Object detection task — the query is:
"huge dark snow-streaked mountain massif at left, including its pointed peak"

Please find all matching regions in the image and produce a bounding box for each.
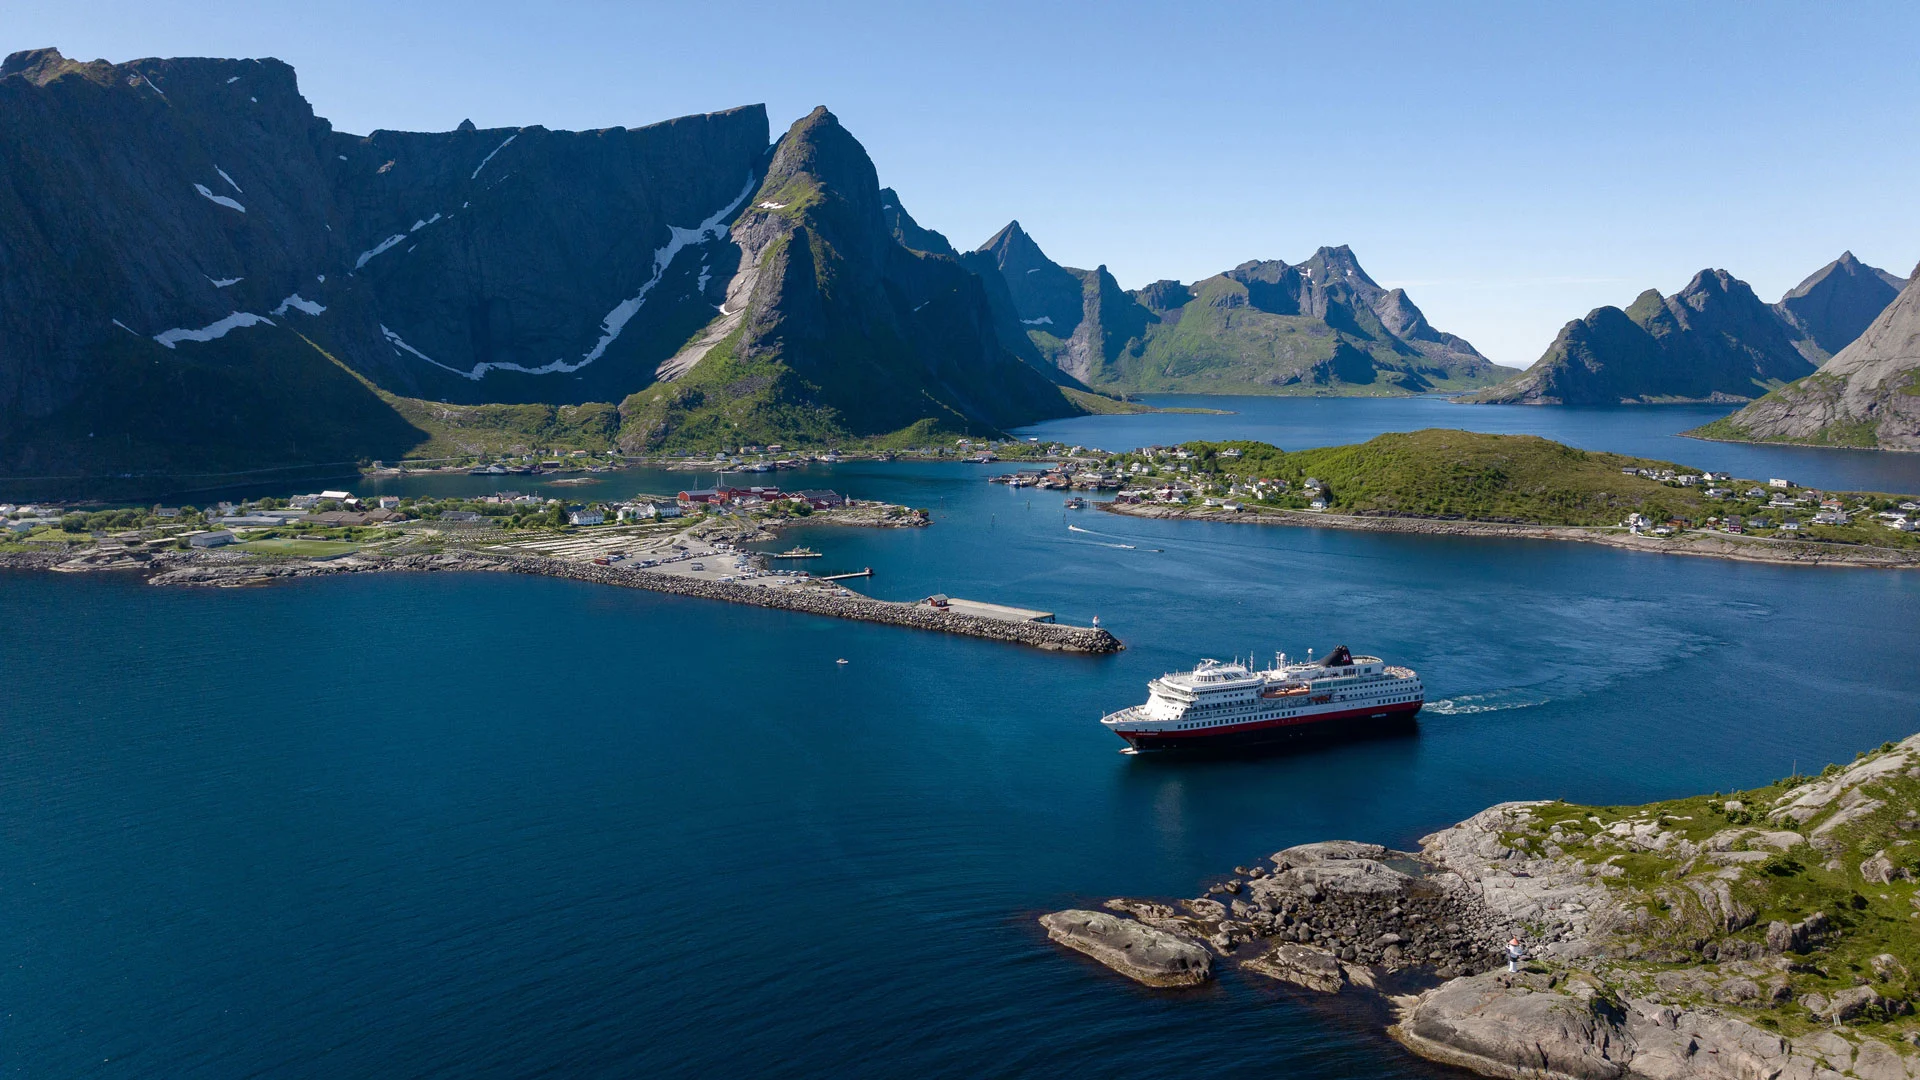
[0,50,1075,473]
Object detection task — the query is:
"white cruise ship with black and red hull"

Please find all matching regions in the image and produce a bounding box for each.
[1100,646,1427,753]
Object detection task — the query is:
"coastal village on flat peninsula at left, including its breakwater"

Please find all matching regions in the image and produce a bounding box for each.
[0,448,1121,653]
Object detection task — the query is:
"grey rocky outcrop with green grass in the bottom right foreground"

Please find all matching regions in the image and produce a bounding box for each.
[1041,734,1920,1080]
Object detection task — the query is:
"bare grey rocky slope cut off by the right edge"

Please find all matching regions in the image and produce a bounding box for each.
[1693,267,1920,450]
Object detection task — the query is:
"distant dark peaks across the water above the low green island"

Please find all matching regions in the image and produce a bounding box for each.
[1463,252,1905,405]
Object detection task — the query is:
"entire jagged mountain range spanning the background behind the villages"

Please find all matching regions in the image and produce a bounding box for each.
[0,48,1899,479]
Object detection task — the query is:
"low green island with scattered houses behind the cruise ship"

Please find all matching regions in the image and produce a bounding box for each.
[1106,429,1920,565]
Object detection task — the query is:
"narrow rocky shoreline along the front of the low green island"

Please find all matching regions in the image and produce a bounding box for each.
[1094,502,1920,569]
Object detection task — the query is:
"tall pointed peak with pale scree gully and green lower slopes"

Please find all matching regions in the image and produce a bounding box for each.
[622,108,1073,446]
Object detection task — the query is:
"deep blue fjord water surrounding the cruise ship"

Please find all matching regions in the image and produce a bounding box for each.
[0,397,1920,1076]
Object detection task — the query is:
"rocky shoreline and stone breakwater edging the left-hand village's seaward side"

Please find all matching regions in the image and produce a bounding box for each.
[0,548,1123,655]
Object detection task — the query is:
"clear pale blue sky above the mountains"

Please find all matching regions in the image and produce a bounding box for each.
[0,0,1920,367]
